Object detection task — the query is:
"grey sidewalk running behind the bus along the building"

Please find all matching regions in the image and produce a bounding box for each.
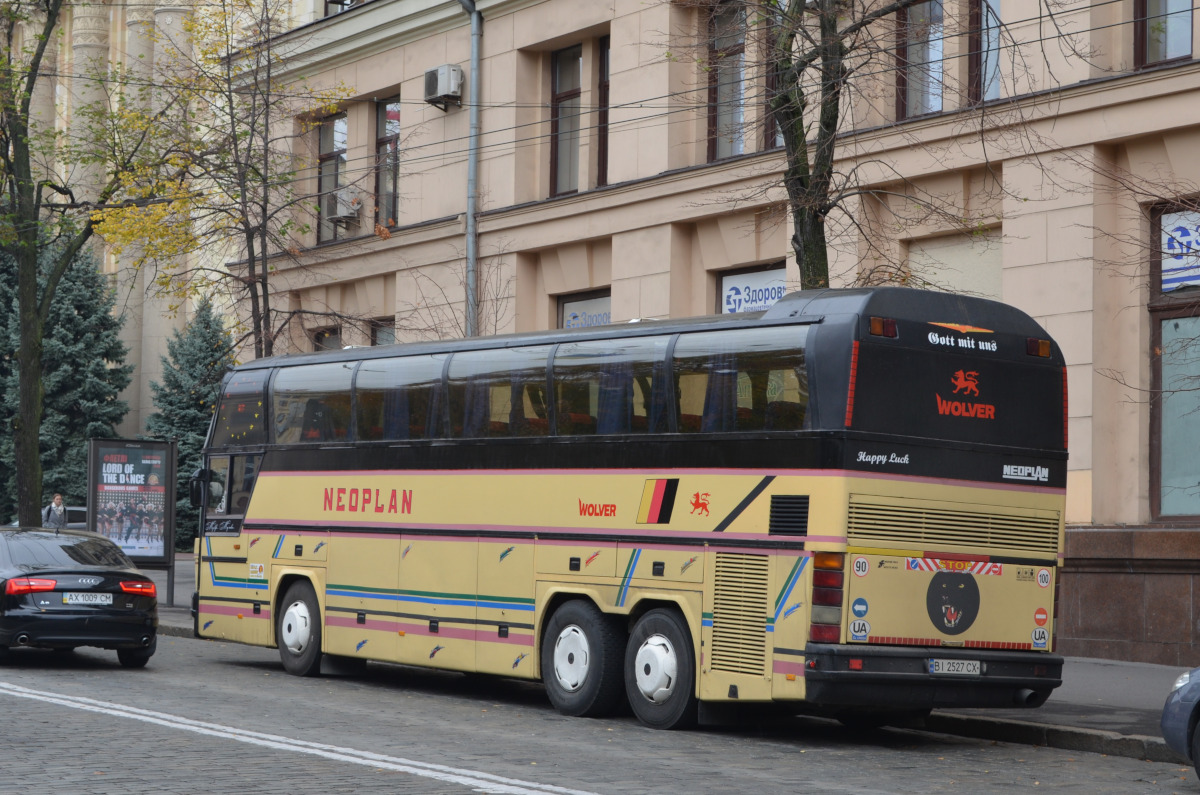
[146,552,1187,764]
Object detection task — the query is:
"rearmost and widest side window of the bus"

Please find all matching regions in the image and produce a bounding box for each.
[672,327,809,434]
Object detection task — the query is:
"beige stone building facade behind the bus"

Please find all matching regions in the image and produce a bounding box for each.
[87,0,1200,664]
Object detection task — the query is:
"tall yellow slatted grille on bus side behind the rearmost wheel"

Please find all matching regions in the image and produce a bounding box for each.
[709,552,768,675]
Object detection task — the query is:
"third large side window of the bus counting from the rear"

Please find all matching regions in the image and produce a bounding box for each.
[448,345,550,438]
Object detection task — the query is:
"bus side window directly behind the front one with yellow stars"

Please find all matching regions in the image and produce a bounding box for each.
[271,361,354,444]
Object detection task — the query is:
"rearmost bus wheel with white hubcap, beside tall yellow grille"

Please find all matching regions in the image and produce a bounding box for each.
[625,608,697,729]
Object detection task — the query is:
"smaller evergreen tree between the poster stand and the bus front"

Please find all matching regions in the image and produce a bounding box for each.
[146,299,234,549]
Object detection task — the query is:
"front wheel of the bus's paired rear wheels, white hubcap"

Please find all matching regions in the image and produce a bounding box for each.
[541,599,625,717]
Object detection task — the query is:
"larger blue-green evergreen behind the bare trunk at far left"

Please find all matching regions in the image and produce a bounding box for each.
[0,247,133,518]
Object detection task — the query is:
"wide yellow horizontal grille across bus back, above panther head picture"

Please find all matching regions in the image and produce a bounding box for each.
[847,495,1062,555]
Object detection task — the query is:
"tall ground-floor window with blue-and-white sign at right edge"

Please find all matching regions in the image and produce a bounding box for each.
[1150,207,1200,520]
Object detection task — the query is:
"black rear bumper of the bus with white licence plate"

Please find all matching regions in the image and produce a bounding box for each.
[804,644,1063,710]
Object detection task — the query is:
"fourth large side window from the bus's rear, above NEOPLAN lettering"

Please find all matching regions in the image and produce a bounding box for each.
[354,354,446,441]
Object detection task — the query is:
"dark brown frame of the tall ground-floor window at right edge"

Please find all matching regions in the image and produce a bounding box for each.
[1146,199,1200,525]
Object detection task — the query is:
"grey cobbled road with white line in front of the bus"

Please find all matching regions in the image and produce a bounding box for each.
[0,636,1200,795]
